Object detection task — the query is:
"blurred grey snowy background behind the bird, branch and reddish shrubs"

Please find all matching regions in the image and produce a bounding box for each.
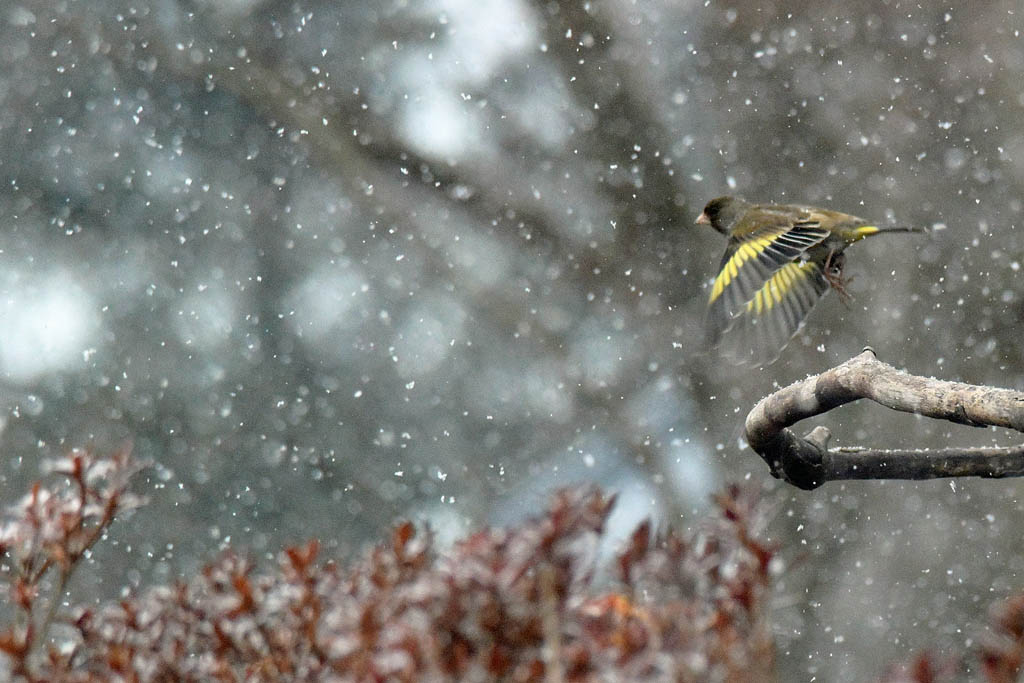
[0,0,1024,681]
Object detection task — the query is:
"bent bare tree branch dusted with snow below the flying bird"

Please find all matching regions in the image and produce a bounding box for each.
[746,348,1024,489]
